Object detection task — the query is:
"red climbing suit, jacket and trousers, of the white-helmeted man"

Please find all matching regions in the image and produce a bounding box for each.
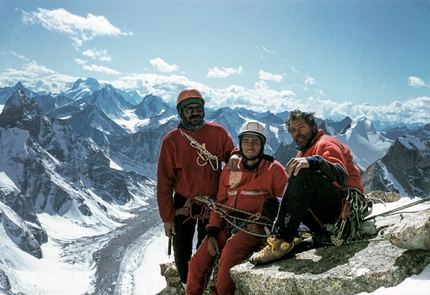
[186,160,287,295]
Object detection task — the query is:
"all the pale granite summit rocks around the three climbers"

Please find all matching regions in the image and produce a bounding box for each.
[160,199,430,295]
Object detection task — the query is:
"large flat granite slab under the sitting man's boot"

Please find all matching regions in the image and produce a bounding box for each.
[231,241,430,295]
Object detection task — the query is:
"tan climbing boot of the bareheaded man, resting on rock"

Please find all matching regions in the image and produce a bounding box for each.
[249,237,295,265]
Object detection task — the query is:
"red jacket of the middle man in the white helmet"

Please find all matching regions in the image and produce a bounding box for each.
[206,159,288,228]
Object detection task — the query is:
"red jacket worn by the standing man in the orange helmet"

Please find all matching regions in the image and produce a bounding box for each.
[157,122,234,222]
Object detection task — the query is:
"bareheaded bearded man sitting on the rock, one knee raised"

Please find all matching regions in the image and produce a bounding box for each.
[250,110,364,265]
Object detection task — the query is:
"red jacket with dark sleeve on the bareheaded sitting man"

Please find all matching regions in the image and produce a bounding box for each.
[297,129,364,194]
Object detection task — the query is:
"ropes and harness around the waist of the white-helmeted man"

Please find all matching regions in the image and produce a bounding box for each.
[195,196,272,238]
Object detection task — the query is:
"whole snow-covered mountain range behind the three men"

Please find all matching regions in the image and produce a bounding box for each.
[0,78,430,294]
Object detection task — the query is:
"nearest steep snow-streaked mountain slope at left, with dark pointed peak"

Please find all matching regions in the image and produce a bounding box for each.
[0,91,159,294]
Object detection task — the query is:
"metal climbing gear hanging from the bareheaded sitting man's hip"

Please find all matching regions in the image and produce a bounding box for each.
[325,190,376,246]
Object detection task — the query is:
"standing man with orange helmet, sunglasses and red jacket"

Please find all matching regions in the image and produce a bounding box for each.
[157,89,234,285]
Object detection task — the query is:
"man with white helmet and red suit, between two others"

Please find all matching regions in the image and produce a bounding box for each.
[186,121,287,294]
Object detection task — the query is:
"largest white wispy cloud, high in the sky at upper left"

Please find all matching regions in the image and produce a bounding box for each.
[22,8,133,46]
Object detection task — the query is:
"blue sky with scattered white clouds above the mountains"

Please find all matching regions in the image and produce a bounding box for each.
[0,0,430,123]
